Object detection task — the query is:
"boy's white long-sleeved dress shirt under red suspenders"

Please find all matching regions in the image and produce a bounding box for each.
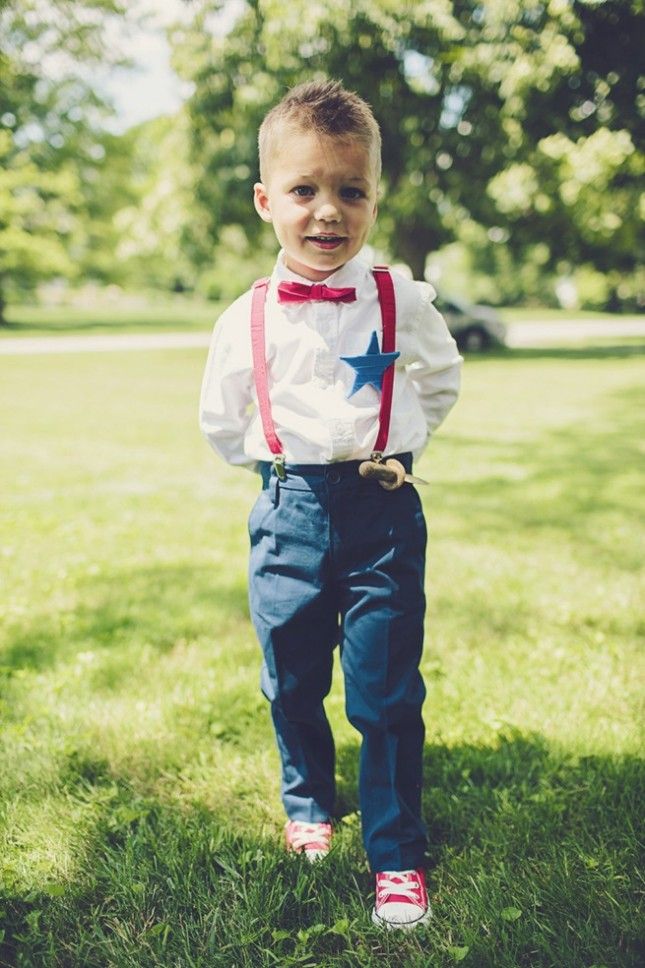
[200,252,462,467]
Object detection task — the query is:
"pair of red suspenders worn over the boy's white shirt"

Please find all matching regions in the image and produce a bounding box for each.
[251,266,396,466]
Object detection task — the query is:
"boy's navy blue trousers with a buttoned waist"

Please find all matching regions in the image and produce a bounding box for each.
[249,454,427,871]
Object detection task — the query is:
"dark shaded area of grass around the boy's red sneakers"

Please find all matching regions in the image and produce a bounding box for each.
[0,734,643,968]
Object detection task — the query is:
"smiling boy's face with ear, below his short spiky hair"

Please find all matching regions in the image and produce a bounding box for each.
[254,126,377,282]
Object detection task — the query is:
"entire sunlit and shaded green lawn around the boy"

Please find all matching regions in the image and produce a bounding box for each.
[0,347,645,968]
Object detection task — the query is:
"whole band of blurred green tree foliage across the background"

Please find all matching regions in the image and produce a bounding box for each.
[0,0,645,313]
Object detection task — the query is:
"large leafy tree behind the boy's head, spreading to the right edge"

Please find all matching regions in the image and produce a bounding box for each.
[175,0,643,304]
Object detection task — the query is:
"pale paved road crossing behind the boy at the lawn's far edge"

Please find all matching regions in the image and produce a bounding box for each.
[0,316,645,356]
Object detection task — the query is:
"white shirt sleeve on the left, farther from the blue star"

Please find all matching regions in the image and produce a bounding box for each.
[199,294,256,469]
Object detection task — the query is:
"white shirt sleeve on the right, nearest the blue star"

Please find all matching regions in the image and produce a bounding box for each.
[406,283,463,437]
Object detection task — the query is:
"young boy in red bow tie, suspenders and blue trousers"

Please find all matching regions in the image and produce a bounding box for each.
[201,82,461,929]
